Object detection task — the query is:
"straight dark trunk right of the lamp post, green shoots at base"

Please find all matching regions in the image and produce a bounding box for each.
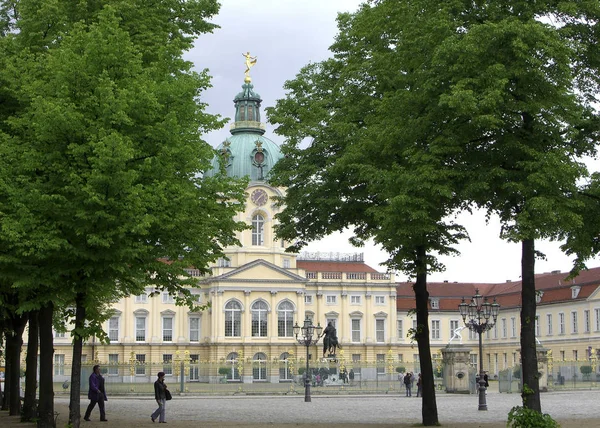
[521,239,542,413]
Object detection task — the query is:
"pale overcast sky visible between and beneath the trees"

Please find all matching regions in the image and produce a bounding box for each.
[188,0,600,282]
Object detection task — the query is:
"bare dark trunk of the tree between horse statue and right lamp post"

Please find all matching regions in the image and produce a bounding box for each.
[413,247,439,426]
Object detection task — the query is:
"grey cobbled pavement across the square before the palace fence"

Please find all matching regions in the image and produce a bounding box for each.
[48,390,600,427]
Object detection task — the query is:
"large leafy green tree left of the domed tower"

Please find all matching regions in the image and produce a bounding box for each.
[0,0,245,426]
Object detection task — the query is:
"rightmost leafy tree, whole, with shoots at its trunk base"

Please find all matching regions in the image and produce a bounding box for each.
[426,1,600,412]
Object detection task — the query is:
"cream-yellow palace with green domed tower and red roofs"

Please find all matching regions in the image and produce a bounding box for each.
[50,72,600,383]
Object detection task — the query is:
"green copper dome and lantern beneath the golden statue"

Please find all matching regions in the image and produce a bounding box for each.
[206,82,283,181]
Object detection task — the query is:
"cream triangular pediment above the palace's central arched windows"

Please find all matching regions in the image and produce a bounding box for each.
[209,259,307,284]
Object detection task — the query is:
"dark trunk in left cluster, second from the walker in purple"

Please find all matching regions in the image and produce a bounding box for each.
[38,302,56,428]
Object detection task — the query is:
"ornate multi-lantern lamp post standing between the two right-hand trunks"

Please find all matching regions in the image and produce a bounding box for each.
[458,289,500,410]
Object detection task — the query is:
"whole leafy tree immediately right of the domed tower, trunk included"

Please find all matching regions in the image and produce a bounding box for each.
[268,1,474,426]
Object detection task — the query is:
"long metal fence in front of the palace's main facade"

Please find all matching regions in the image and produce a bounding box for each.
[49,361,443,395]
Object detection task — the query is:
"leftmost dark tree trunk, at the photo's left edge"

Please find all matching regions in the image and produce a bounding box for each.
[6,315,27,416]
